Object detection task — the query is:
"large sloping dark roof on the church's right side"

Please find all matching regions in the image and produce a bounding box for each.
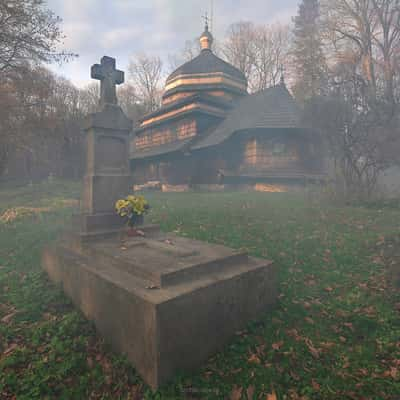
[192,84,301,150]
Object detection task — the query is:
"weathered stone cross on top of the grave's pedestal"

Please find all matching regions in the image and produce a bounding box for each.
[91,56,124,107]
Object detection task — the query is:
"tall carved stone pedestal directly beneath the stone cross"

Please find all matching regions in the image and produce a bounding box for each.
[81,105,132,234]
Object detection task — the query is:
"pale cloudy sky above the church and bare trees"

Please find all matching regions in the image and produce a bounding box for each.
[48,0,298,86]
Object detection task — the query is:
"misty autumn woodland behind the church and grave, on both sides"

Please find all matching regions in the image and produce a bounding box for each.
[0,0,400,197]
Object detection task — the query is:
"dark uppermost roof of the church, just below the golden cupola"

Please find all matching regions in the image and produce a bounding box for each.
[167,49,247,84]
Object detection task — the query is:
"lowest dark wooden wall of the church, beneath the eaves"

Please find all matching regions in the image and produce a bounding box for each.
[132,132,321,185]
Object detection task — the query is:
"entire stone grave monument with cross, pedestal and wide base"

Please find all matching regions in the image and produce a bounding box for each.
[43,57,277,388]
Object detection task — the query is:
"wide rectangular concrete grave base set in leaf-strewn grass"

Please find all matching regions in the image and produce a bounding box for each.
[43,227,277,389]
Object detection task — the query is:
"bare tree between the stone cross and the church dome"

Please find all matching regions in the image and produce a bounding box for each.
[128,54,163,112]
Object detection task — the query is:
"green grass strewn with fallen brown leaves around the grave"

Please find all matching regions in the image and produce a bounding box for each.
[0,182,400,400]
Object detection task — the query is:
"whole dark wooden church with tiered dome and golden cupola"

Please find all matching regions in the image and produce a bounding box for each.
[131,25,323,191]
